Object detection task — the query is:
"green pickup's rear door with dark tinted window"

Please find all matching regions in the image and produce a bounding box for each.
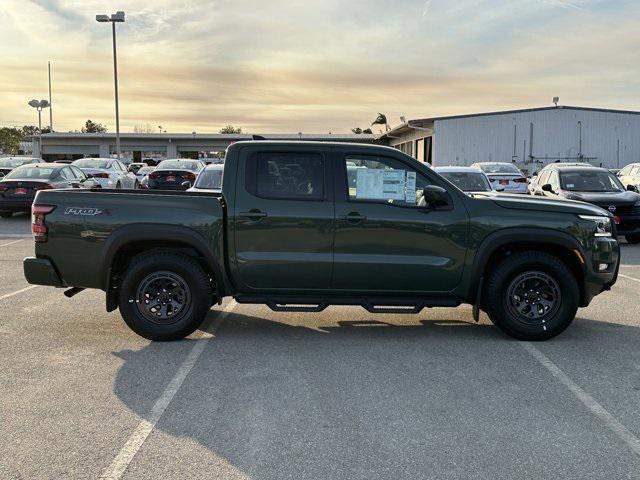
[232,146,334,293]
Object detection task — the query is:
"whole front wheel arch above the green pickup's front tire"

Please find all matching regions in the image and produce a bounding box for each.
[468,228,586,303]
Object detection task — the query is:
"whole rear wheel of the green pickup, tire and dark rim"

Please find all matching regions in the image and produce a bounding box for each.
[118,251,211,341]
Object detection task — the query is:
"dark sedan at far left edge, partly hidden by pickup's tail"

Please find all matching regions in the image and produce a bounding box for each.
[0,162,99,218]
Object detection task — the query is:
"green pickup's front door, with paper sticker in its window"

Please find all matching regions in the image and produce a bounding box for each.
[332,155,468,294]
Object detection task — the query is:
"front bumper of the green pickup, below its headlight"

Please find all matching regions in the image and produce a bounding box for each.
[580,237,620,307]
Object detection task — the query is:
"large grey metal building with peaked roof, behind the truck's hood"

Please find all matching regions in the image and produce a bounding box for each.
[378,106,640,173]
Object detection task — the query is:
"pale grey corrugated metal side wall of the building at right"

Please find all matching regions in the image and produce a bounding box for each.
[434,108,640,171]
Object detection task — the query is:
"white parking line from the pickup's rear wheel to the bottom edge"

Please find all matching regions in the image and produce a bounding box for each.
[100,300,238,480]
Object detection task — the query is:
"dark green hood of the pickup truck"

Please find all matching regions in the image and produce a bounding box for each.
[472,192,612,217]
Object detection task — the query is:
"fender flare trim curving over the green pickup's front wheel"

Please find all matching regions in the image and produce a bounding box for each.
[468,227,587,299]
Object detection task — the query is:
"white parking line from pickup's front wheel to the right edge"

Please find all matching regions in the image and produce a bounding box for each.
[521,342,640,456]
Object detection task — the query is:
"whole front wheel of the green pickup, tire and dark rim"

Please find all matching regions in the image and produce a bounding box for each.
[483,251,580,340]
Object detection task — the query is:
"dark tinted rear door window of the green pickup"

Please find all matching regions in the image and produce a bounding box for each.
[249,152,324,200]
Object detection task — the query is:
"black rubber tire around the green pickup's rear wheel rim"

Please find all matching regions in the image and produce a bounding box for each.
[118,250,212,341]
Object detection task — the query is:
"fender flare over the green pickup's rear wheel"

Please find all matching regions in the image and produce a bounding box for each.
[100,223,226,297]
